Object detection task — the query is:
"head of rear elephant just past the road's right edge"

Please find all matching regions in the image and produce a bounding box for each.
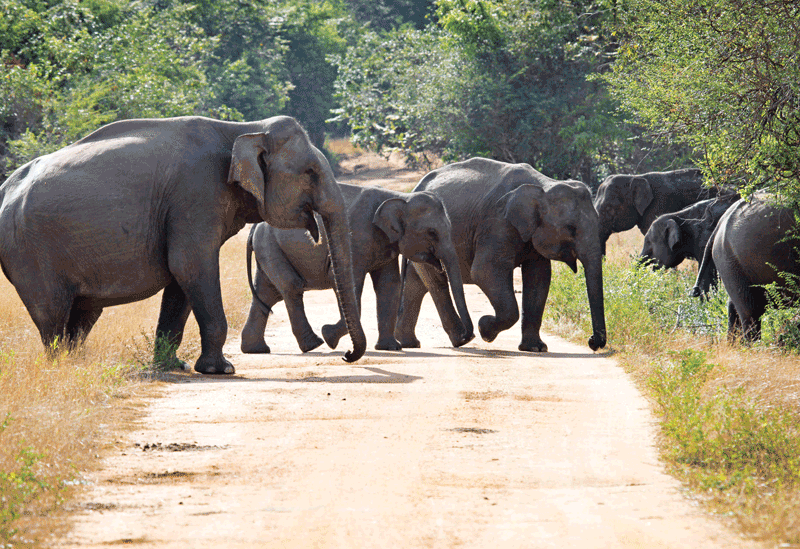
[594,175,654,254]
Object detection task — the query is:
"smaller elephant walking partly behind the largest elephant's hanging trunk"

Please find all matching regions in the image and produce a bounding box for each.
[241,184,475,353]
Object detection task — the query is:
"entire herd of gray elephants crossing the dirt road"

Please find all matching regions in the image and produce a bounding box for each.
[0,116,798,374]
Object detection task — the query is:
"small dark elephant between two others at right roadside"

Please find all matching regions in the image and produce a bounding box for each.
[640,194,739,268]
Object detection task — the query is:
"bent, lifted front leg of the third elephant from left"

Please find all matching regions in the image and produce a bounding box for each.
[470,250,519,342]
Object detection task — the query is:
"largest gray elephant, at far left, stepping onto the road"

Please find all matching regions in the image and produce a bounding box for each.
[0,116,366,374]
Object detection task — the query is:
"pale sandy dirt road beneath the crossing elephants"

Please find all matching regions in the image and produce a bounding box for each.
[61,272,755,549]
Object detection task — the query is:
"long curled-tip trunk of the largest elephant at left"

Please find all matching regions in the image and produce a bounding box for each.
[314,180,367,362]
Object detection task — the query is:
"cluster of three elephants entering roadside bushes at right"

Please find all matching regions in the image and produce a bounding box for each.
[595,170,800,341]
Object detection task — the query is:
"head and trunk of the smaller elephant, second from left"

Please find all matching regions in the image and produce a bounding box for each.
[372,192,474,339]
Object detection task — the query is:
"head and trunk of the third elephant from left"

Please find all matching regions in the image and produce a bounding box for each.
[501,181,606,351]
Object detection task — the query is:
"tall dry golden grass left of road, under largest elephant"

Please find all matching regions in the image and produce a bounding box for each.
[0,232,250,547]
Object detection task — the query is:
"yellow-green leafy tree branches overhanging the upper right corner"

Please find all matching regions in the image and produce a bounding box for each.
[608,0,800,196]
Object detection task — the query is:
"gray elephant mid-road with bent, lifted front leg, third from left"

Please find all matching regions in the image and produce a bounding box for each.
[395,158,606,352]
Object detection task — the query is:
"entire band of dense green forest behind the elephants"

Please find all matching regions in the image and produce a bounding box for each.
[0,0,800,197]
